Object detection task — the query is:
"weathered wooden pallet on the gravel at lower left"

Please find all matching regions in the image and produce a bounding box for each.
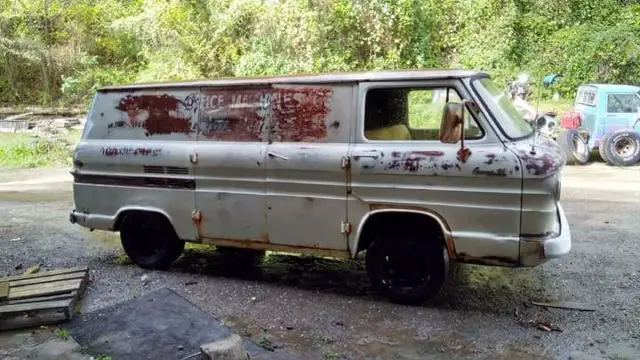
[0,266,89,330]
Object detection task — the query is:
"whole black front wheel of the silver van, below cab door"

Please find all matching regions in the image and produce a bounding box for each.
[366,228,449,304]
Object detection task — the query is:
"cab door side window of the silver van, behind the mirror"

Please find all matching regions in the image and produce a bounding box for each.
[364,88,483,141]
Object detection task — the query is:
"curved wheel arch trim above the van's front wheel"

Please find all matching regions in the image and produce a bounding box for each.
[350,206,456,259]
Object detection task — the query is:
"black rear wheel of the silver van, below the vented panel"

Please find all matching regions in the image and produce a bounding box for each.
[120,211,184,269]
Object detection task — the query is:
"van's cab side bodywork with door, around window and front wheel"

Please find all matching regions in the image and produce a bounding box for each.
[349,80,522,265]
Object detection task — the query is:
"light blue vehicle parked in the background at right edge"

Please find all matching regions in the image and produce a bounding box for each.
[559,84,640,166]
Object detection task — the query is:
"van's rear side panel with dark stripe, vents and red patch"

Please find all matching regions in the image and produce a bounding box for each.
[73,89,199,240]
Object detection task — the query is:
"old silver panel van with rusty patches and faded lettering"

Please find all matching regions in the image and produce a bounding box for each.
[70,70,571,303]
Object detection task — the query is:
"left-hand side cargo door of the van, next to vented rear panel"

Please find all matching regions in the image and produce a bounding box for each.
[195,87,267,242]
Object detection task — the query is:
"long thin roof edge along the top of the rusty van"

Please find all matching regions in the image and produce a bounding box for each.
[99,69,488,91]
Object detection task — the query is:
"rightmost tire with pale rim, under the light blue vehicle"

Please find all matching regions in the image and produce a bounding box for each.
[601,129,640,166]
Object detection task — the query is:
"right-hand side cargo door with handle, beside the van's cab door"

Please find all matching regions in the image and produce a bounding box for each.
[266,85,353,255]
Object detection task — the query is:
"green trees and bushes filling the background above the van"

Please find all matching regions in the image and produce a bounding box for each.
[0,0,640,105]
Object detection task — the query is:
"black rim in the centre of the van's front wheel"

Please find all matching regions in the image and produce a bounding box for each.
[382,239,431,288]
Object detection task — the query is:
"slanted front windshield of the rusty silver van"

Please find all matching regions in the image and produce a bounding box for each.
[473,78,534,140]
